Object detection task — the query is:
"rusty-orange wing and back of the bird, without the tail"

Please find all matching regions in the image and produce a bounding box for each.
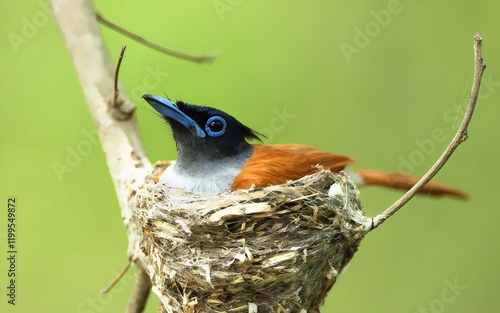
[231,144,354,190]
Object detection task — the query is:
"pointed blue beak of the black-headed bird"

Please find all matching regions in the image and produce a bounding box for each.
[142,94,206,138]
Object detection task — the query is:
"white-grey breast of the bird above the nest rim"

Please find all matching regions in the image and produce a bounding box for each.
[160,163,241,194]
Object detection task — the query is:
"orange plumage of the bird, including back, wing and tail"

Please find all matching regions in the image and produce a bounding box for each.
[231,144,467,199]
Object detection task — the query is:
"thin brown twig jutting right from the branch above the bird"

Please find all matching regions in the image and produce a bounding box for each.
[95,11,216,63]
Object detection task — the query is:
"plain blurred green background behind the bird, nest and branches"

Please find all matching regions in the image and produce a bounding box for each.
[0,0,500,313]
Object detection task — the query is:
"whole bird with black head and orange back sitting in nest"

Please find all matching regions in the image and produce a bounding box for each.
[142,94,468,200]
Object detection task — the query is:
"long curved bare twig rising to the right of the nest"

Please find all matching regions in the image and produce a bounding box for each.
[372,34,486,230]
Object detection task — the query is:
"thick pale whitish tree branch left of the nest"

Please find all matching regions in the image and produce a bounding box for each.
[52,0,151,313]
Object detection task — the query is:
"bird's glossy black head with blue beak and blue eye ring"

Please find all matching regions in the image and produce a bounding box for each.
[142,94,260,166]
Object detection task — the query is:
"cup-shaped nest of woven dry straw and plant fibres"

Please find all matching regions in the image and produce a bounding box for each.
[135,162,371,313]
